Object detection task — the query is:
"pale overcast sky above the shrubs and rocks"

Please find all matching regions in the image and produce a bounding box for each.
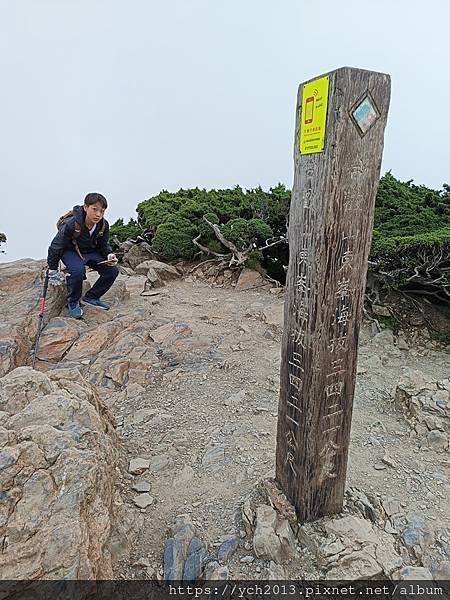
[0,0,450,261]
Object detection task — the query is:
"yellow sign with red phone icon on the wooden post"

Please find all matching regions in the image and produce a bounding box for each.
[300,77,329,154]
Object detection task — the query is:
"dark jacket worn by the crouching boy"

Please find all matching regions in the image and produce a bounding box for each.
[47,206,112,269]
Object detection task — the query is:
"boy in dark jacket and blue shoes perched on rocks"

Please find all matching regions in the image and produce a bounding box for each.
[47,194,119,319]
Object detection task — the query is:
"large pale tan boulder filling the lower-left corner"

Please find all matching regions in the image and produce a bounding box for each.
[0,367,118,580]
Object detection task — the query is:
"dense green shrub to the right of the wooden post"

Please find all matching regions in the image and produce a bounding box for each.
[370,173,450,302]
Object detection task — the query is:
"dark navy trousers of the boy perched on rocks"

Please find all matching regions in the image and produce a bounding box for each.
[61,250,119,304]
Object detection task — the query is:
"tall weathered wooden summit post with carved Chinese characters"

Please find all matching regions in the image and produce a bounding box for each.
[276,67,390,521]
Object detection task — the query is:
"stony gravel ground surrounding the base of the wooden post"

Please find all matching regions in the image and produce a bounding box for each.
[0,258,450,579]
